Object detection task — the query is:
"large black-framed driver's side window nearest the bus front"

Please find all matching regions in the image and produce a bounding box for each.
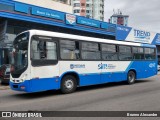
[31,36,58,66]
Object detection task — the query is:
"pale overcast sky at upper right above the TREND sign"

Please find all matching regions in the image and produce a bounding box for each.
[105,0,160,33]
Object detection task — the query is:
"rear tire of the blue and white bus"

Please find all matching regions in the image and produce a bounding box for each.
[127,71,136,85]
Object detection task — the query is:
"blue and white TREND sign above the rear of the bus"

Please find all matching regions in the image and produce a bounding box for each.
[116,25,160,45]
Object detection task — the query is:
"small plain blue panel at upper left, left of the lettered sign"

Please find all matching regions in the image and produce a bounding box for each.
[15,3,29,13]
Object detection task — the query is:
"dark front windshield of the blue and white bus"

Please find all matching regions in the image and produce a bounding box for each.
[11,33,29,75]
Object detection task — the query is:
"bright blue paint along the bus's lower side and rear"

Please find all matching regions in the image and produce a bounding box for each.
[10,61,157,92]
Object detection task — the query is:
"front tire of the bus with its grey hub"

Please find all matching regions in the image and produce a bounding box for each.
[61,75,77,94]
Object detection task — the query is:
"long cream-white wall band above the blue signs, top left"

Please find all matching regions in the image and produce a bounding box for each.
[14,0,73,13]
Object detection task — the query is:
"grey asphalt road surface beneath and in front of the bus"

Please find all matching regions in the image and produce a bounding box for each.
[0,75,160,120]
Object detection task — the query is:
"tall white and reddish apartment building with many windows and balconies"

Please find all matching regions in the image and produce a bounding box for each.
[71,0,104,21]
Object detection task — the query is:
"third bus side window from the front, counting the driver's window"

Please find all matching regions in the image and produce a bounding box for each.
[81,42,101,60]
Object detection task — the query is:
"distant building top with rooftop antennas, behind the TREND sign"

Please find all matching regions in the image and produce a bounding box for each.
[109,11,129,26]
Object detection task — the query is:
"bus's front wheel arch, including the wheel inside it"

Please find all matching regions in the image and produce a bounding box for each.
[61,73,79,94]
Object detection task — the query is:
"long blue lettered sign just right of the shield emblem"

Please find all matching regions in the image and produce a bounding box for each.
[77,17,100,28]
